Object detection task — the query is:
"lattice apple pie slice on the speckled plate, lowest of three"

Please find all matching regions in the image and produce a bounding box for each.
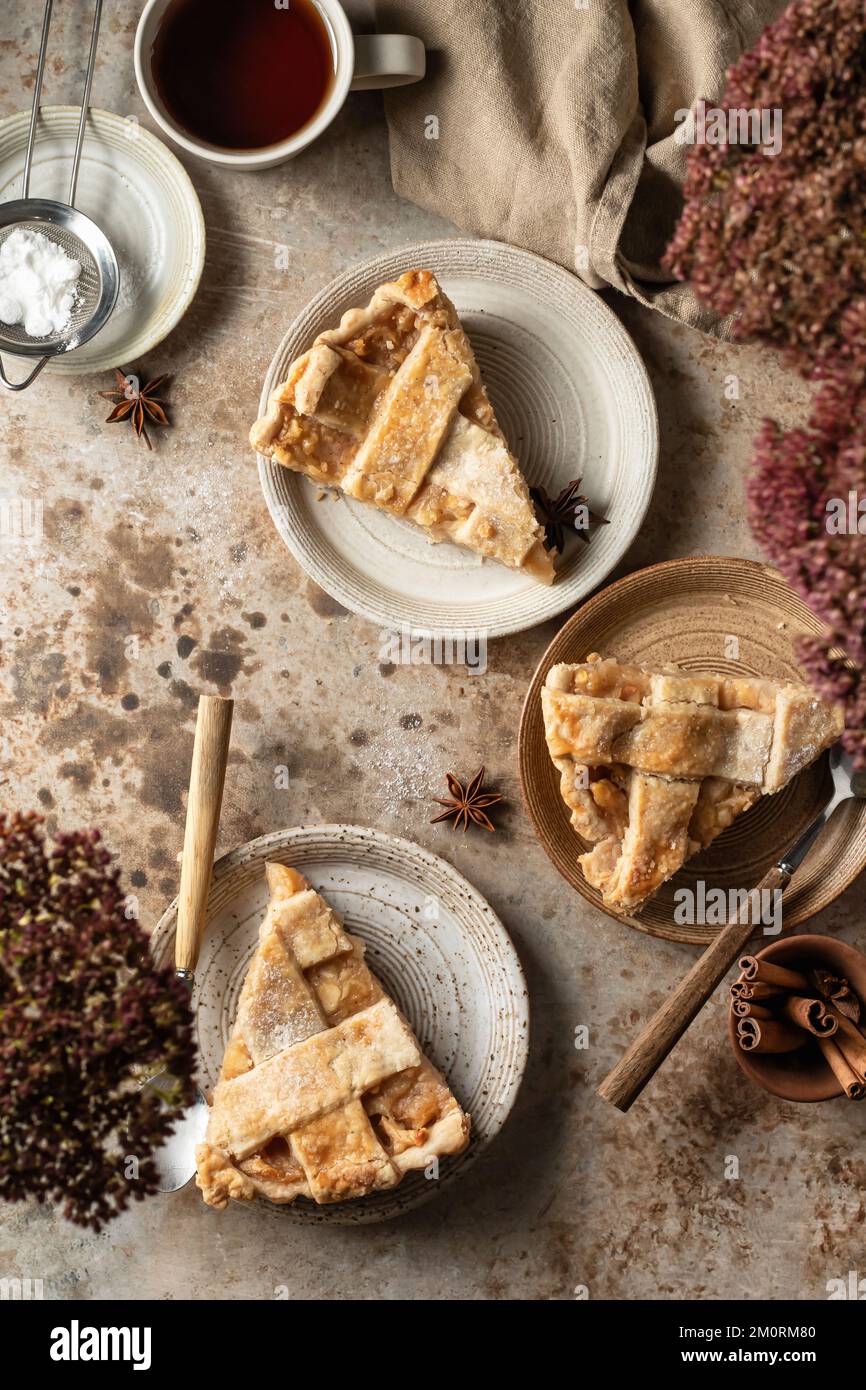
[196,863,470,1208]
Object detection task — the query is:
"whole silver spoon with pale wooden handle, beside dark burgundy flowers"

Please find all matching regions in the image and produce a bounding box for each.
[142,695,235,1193]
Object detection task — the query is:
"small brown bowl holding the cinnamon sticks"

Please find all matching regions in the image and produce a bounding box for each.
[728,935,866,1101]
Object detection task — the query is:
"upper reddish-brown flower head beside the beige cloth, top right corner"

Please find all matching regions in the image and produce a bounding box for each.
[666,0,866,375]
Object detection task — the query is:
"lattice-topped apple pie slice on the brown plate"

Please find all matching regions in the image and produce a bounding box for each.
[541,653,842,912]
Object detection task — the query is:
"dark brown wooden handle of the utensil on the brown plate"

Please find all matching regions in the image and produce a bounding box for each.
[598,865,791,1111]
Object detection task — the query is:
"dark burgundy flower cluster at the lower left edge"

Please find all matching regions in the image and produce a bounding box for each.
[0,813,195,1230]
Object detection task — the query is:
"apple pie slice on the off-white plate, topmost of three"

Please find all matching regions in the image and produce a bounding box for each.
[250,270,553,584]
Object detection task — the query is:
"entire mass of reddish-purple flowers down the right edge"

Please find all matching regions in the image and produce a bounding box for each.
[667,0,866,766]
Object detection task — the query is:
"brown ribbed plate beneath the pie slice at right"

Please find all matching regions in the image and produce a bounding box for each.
[518,555,866,945]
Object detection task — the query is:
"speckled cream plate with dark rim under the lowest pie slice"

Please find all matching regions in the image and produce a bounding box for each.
[153,826,530,1226]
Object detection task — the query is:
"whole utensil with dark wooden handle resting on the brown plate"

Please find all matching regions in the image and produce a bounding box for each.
[598,744,866,1111]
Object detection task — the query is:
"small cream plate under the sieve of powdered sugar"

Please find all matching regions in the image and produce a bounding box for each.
[0,106,204,375]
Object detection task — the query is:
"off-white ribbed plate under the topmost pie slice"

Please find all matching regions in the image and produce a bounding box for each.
[250,240,657,637]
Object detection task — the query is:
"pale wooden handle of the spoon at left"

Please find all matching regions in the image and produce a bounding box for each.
[174,695,235,972]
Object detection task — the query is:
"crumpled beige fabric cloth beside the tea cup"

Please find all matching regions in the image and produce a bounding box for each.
[377,0,785,329]
